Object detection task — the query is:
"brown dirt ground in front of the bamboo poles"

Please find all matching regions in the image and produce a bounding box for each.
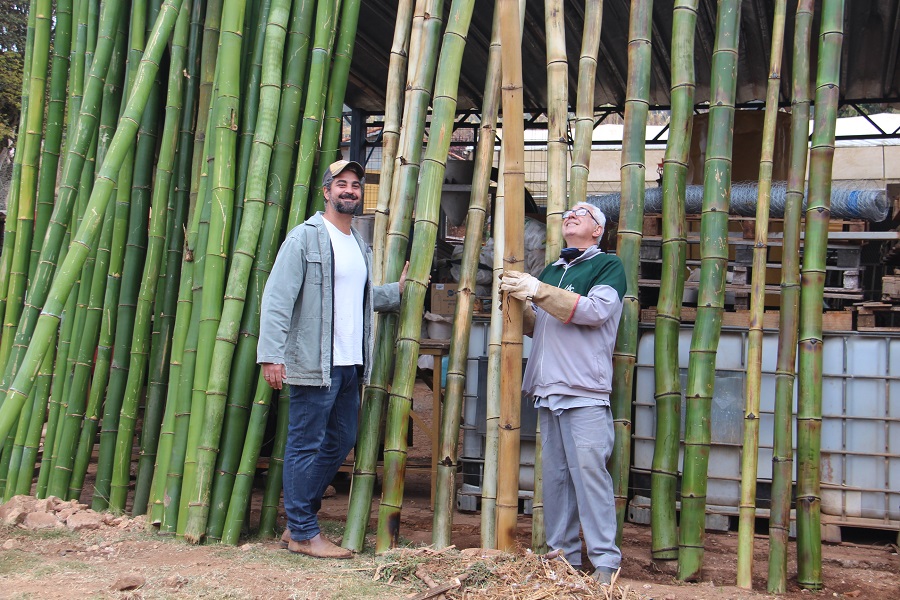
[0,385,900,600]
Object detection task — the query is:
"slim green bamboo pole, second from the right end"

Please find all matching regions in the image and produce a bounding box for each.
[768,0,814,594]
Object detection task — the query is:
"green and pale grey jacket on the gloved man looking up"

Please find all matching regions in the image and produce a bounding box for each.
[522,247,625,404]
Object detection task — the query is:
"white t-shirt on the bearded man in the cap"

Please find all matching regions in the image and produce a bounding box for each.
[324,219,368,366]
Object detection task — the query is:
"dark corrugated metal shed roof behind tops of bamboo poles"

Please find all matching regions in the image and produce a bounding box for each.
[346,0,900,113]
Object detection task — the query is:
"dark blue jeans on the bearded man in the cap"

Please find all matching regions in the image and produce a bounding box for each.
[284,366,359,541]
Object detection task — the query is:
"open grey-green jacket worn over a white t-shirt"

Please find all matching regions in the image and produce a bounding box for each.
[256,212,400,387]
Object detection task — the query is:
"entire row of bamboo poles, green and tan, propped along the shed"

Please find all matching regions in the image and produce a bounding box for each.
[0,0,844,591]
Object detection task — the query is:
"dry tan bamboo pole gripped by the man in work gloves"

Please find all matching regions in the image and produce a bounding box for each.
[496,0,525,551]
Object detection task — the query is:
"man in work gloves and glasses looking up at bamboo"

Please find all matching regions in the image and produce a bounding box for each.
[500,203,625,583]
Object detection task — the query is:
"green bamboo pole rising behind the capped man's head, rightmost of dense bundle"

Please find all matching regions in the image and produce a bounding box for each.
[312,0,362,211]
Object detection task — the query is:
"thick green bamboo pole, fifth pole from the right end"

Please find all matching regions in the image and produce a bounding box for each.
[650,0,699,560]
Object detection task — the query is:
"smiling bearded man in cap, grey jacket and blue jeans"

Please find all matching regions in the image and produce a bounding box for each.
[257,160,406,558]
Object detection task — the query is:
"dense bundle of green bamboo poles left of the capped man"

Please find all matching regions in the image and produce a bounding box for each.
[0,0,368,543]
